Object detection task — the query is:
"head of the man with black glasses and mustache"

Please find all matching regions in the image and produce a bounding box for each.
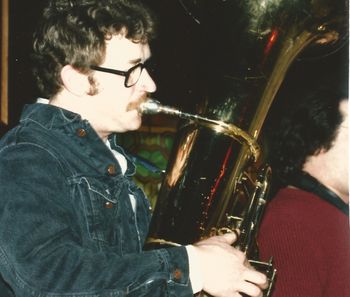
[33,0,155,137]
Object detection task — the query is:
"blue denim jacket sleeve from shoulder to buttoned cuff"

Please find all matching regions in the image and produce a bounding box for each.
[0,144,192,297]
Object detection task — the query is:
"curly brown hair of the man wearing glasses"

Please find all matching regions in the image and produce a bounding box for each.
[33,0,155,98]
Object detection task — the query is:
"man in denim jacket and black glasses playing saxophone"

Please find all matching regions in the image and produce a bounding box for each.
[0,0,266,297]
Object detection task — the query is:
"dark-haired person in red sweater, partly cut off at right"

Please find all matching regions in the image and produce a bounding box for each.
[258,78,350,297]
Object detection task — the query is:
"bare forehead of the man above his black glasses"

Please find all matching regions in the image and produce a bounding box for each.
[103,34,151,65]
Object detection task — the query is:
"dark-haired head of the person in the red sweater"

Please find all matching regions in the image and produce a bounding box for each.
[269,84,348,200]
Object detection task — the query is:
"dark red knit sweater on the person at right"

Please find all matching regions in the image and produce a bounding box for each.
[258,188,350,297]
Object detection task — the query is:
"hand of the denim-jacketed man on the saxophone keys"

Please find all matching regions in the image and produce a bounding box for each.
[193,233,267,297]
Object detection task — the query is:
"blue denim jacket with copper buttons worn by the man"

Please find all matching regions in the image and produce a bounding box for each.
[0,103,192,297]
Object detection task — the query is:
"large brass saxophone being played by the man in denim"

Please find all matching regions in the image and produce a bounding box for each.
[140,0,348,296]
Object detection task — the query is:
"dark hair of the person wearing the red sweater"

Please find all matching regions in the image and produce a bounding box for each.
[267,83,348,185]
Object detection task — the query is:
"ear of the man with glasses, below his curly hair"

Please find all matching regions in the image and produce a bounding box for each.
[61,65,91,96]
